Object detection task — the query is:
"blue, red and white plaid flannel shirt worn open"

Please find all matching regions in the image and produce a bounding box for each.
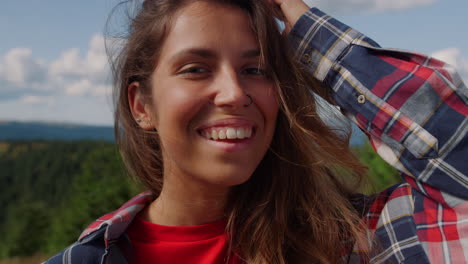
[46,8,468,264]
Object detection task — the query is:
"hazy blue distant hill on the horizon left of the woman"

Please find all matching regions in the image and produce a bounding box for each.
[0,121,114,142]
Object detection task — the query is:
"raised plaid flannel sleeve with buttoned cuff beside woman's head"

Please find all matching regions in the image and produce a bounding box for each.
[289,8,468,204]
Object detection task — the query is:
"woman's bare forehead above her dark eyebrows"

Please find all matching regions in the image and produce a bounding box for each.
[161,1,258,56]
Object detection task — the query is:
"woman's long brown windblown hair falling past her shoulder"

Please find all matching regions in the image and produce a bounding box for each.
[110,0,372,264]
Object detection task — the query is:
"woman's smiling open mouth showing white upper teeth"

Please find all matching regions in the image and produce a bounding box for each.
[199,126,255,142]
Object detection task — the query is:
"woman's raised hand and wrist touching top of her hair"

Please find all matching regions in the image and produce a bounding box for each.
[268,0,309,34]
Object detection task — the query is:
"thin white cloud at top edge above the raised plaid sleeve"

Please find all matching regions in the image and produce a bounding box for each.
[305,0,436,14]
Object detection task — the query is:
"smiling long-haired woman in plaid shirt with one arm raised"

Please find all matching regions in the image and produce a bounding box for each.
[47,0,468,263]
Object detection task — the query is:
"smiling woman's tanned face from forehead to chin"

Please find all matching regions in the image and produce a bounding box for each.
[146,1,278,187]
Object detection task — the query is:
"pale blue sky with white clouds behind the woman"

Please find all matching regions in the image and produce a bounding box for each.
[0,0,468,125]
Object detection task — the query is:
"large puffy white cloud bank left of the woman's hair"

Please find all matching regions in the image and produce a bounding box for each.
[0,35,111,100]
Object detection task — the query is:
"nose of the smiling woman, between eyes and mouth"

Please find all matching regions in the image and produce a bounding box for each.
[213,71,249,108]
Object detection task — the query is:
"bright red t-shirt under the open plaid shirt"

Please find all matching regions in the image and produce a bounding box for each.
[127,216,240,264]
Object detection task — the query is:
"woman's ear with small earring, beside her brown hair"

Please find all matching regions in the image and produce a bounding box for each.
[127,82,155,130]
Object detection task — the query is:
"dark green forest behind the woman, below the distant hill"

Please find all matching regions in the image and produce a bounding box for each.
[0,141,399,263]
